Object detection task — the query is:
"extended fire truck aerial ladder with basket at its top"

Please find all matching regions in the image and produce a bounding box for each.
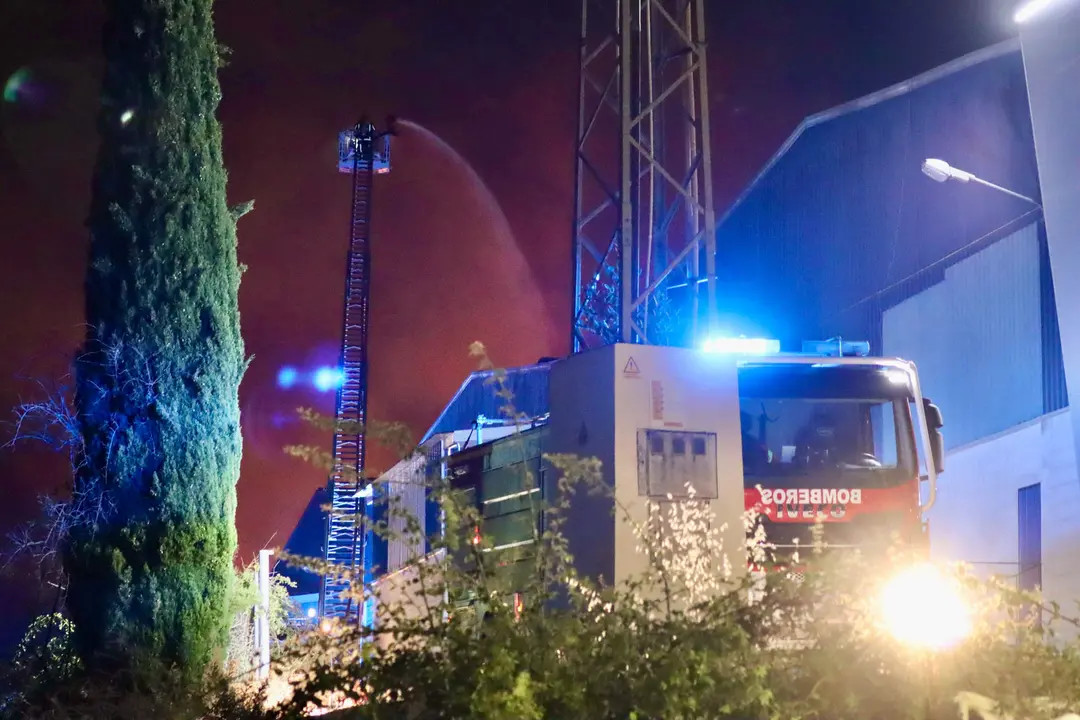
[319,120,392,622]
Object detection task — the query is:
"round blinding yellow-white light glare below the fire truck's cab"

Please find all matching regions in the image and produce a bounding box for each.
[881,562,971,650]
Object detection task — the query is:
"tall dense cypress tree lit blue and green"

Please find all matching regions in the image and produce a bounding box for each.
[65,0,245,677]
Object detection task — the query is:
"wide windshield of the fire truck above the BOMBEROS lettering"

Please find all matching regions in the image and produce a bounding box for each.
[739,364,917,487]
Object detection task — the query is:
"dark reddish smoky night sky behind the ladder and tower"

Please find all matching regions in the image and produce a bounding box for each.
[0,0,1014,651]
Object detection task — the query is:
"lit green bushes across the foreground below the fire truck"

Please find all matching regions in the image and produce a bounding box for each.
[252,345,1080,720]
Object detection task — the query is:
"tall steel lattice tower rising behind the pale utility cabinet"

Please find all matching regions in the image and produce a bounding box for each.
[571,0,717,352]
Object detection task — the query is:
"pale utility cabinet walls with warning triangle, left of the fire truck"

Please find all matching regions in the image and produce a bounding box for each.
[548,344,745,583]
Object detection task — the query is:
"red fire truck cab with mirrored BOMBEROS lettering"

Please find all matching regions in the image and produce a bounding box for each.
[721,340,944,558]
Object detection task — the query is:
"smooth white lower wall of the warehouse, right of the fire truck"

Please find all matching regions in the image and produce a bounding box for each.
[930,409,1080,610]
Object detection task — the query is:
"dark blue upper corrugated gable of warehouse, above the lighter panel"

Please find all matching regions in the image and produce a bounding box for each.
[717,44,1038,352]
